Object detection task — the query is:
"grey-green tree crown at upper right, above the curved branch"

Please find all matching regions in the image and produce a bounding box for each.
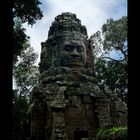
[102,17,127,52]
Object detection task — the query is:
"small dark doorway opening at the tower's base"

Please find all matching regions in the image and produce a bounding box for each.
[74,128,88,140]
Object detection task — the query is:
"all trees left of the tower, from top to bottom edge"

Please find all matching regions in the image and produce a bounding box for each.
[12,0,43,140]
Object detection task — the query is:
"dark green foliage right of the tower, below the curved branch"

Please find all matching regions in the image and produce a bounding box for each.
[95,58,128,103]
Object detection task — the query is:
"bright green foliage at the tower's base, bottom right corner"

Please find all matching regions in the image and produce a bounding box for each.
[96,127,128,140]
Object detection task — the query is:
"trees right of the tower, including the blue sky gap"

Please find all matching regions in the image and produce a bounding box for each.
[90,16,128,103]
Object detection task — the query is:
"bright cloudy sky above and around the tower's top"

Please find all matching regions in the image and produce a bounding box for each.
[23,0,127,64]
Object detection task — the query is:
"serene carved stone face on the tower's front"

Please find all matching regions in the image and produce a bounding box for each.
[60,41,86,67]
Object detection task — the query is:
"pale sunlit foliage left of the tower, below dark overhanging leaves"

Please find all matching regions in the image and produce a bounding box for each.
[13,47,39,96]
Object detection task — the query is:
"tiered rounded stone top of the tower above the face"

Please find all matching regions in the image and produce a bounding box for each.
[48,12,87,38]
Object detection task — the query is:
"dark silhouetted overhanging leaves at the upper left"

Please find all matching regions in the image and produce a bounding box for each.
[13,0,43,64]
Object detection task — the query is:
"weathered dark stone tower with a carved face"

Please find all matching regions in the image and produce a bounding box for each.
[29,12,127,140]
